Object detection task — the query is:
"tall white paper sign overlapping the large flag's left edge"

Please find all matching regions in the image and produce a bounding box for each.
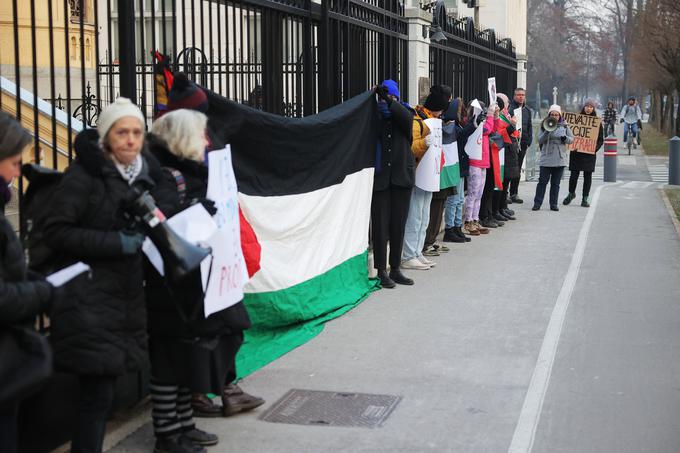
[201,145,248,317]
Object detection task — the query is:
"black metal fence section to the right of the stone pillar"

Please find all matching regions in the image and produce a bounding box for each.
[430,8,517,101]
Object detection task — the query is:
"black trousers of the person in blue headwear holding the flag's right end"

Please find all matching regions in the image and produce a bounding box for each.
[371,186,412,271]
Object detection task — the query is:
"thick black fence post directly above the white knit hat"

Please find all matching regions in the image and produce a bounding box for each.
[118,0,137,100]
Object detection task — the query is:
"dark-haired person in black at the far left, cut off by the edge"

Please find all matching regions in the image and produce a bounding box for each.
[0,112,55,453]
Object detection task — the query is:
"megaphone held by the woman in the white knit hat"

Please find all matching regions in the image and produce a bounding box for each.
[126,188,212,283]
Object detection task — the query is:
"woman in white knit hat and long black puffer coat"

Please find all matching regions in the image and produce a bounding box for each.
[45,98,190,452]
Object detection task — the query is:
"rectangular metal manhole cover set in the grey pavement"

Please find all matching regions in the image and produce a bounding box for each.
[260,389,401,428]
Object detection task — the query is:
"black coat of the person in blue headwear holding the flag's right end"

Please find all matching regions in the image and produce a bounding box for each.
[373,101,416,191]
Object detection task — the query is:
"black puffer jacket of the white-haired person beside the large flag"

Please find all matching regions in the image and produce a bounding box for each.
[146,134,250,337]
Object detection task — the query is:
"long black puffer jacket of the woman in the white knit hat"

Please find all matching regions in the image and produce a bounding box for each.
[45,129,170,376]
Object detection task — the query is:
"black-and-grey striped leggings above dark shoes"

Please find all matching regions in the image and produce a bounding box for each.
[149,377,195,437]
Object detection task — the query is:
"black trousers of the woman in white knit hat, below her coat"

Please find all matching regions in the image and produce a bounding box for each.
[71,376,116,453]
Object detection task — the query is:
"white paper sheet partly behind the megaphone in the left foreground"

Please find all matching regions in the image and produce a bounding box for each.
[142,204,217,278]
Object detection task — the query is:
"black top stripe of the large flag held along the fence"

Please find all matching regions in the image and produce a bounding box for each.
[206,90,381,196]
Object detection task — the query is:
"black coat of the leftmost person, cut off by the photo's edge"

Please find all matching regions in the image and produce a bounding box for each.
[0,202,52,326]
